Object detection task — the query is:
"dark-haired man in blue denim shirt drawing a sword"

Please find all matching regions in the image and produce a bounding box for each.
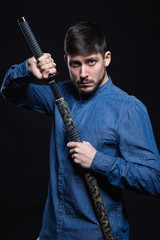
[2,22,160,240]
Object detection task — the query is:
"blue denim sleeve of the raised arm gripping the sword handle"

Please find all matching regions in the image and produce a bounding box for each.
[1,60,54,115]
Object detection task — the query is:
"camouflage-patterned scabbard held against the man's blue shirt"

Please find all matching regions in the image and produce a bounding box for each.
[56,98,114,240]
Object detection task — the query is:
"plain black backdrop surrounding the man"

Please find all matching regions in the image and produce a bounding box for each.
[0,0,160,240]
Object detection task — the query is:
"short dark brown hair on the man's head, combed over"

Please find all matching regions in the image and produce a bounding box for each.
[64,22,107,57]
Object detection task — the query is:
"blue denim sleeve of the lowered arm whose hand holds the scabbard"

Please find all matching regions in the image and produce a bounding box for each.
[91,103,160,195]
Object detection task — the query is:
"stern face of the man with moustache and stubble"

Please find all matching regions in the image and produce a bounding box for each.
[65,52,111,95]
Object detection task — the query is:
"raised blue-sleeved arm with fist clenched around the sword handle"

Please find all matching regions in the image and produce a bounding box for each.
[1,54,56,113]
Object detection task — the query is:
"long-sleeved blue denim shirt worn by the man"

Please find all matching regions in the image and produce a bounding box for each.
[2,62,160,240]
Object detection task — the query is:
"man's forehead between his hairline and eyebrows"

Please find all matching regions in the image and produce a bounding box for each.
[67,53,102,62]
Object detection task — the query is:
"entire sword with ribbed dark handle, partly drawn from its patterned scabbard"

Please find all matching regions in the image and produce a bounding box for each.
[18,17,114,240]
